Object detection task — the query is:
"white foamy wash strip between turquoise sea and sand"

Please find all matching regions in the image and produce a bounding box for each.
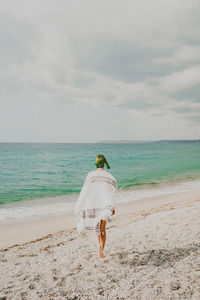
[0,178,200,227]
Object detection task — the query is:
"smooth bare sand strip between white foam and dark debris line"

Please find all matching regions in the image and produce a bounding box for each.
[0,191,200,250]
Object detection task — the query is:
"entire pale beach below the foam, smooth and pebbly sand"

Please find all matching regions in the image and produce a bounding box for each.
[0,191,200,300]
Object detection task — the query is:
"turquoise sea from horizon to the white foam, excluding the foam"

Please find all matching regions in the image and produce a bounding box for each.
[0,143,200,204]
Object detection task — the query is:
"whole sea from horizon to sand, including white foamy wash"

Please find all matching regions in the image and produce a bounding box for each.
[0,143,200,224]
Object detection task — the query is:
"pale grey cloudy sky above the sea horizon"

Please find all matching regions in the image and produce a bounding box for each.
[0,0,200,142]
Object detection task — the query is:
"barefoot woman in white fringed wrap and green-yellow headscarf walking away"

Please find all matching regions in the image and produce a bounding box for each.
[75,154,117,258]
